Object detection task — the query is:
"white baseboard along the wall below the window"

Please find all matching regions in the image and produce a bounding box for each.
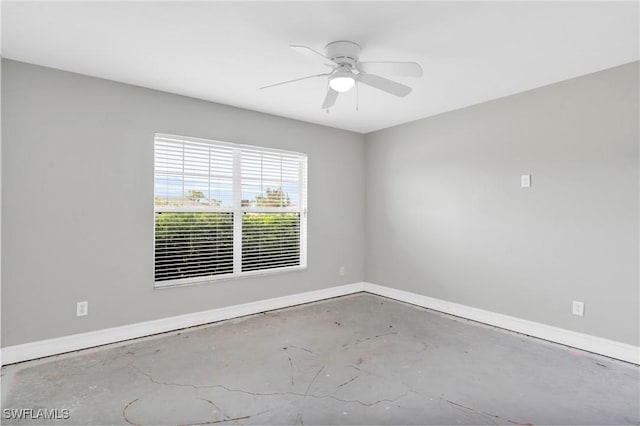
[2,283,364,365]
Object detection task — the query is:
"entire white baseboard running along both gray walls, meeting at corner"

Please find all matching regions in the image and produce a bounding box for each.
[1,282,640,365]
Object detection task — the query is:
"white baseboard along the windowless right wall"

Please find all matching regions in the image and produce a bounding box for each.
[364,283,640,364]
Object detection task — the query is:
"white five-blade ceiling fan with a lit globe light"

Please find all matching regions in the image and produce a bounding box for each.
[260,41,422,109]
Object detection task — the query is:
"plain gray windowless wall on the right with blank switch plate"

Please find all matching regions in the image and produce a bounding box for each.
[364,62,640,345]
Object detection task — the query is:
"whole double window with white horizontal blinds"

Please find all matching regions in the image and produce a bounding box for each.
[154,134,307,287]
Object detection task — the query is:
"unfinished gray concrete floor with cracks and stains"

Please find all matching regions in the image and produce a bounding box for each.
[2,294,640,425]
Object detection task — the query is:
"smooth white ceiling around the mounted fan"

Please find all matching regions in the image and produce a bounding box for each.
[2,1,639,133]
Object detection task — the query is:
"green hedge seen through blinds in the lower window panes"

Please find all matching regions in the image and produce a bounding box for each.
[155,206,300,281]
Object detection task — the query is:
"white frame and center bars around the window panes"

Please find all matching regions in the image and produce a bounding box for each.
[152,133,308,289]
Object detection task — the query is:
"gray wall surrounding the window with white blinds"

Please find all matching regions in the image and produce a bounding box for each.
[2,60,364,346]
